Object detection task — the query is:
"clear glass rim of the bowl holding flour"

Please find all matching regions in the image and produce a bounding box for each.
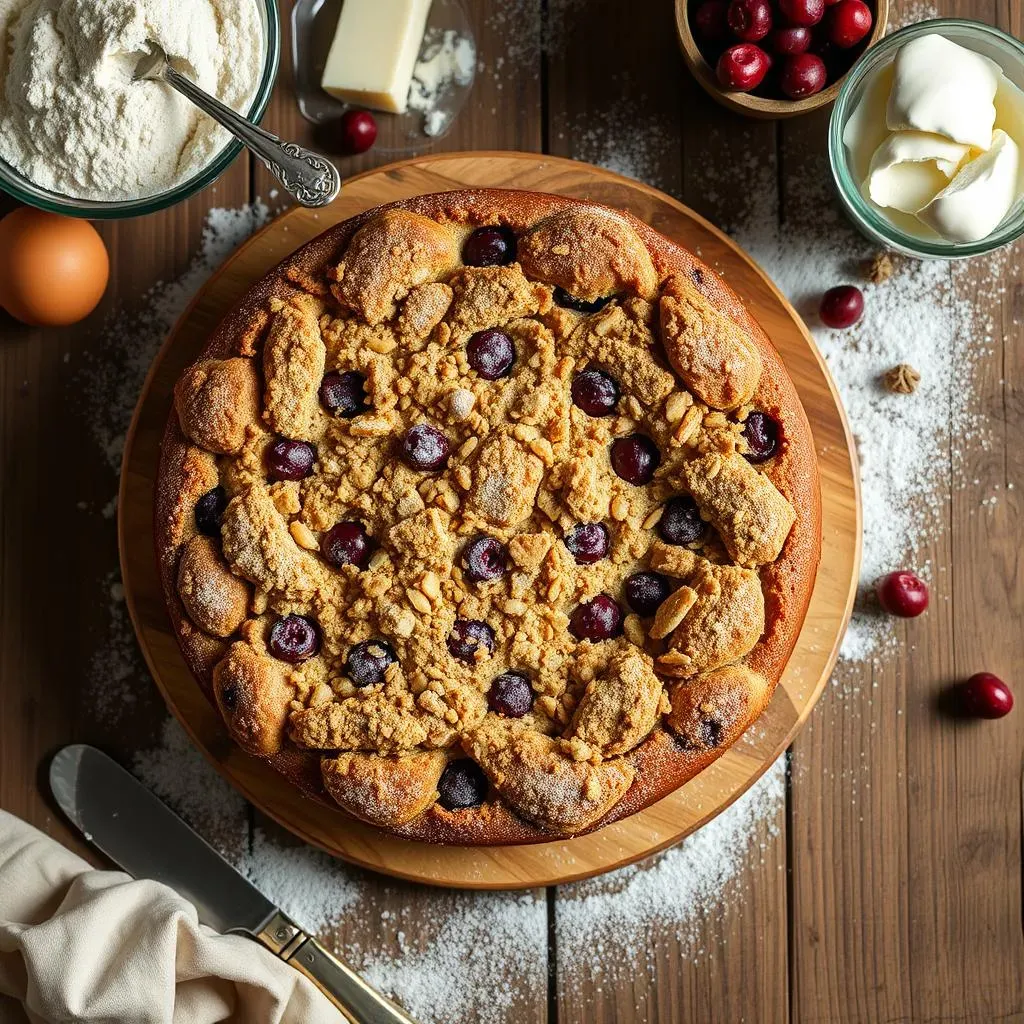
[0,0,281,220]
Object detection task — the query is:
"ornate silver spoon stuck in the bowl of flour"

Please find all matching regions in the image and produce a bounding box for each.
[132,39,341,207]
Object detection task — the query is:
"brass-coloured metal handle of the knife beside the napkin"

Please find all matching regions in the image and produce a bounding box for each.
[256,910,416,1024]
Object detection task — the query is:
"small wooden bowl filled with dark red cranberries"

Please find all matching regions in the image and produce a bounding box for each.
[676,0,888,118]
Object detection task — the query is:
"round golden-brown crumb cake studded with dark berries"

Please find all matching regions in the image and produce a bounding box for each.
[156,190,820,844]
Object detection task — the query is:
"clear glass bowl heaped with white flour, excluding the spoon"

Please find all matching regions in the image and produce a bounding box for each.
[0,0,281,219]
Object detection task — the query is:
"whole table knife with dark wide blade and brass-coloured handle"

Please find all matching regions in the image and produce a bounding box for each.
[49,743,414,1024]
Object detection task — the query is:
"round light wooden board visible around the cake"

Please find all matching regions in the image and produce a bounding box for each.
[118,153,861,889]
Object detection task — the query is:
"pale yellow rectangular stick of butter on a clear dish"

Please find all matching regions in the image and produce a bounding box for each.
[321,0,430,114]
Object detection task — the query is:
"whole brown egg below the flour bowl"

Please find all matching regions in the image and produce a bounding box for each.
[0,207,111,327]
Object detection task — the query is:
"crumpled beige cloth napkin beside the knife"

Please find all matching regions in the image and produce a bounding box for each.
[0,811,343,1024]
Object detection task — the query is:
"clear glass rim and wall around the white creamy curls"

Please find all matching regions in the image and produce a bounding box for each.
[828,17,1024,259]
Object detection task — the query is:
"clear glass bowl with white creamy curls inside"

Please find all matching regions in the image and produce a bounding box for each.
[828,18,1024,259]
